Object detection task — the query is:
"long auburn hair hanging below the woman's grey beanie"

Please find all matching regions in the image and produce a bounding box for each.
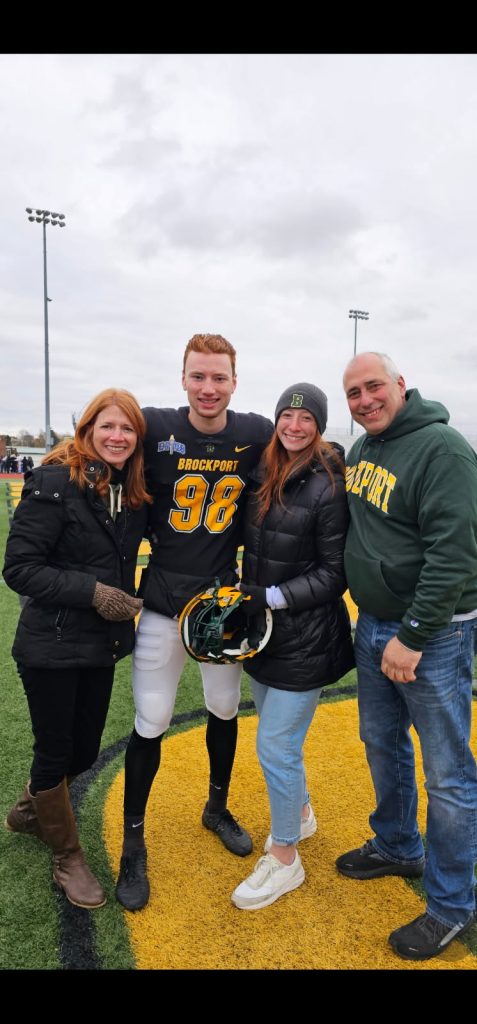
[255,429,345,522]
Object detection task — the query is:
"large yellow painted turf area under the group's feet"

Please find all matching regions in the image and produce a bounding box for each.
[104,699,477,971]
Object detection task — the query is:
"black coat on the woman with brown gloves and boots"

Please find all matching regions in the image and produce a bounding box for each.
[3,462,146,669]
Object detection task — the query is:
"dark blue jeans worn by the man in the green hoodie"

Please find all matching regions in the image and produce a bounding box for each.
[355,613,477,926]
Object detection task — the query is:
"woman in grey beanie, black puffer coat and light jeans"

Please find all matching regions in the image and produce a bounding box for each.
[232,384,354,910]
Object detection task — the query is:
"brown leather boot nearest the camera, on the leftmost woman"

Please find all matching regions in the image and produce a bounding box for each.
[32,778,106,910]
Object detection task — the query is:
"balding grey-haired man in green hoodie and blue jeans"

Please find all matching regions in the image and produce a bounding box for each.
[337,352,477,959]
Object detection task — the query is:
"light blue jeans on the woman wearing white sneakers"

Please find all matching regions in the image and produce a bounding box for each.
[252,679,321,846]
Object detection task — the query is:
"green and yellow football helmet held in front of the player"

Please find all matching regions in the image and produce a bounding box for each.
[179,580,273,665]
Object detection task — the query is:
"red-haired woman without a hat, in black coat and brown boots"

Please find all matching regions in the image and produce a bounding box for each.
[3,388,150,909]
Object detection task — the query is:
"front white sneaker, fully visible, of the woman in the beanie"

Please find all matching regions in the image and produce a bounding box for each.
[231,851,305,910]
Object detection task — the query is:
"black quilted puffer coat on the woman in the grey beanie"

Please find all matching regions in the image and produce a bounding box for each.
[243,452,354,691]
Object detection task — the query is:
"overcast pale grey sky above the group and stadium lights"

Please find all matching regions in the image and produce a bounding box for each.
[0,54,477,434]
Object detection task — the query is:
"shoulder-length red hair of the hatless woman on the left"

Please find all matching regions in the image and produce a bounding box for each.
[42,387,153,509]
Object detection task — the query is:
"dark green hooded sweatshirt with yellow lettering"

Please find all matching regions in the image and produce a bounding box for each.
[345,389,477,650]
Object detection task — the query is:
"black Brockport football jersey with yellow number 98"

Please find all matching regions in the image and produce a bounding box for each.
[139,407,273,616]
